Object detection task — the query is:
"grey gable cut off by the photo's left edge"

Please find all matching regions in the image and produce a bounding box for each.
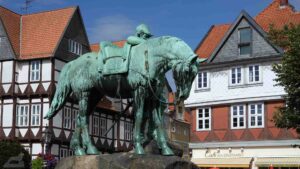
[0,19,15,60]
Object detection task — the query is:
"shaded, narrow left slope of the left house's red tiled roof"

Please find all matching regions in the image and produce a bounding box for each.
[0,6,21,55]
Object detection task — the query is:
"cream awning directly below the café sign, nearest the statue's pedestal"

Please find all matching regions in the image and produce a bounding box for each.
[191,158,252,168]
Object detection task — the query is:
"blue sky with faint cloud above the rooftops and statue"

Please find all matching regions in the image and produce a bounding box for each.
[0,0,300,49]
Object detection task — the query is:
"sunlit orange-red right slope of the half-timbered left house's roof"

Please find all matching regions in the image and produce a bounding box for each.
[19,7,76,59]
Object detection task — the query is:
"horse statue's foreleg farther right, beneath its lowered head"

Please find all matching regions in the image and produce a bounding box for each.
[153,103,174,155]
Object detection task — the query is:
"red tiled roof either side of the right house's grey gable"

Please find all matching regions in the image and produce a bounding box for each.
[195,0,300,58]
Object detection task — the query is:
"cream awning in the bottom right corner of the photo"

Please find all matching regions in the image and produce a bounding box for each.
[255,157,300,167]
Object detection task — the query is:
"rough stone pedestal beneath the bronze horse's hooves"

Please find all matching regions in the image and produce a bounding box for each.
[56,152,198,169]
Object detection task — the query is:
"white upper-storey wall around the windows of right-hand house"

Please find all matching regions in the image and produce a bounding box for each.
[185,63,285,107]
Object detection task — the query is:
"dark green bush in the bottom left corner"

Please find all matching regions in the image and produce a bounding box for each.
[0,141,31,169]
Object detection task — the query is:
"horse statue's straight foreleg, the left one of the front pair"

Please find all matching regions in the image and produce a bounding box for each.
[134,87,145,154]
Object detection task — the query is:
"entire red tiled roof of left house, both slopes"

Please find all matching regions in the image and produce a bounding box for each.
[0,6,77,59]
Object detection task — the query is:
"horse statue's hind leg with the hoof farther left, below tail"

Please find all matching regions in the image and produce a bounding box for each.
[70,114,85,156]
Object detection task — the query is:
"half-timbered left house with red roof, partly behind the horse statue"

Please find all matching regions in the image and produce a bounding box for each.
[0,7,132,158]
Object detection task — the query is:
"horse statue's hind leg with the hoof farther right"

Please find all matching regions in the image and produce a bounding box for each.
[79,92,99,154]
